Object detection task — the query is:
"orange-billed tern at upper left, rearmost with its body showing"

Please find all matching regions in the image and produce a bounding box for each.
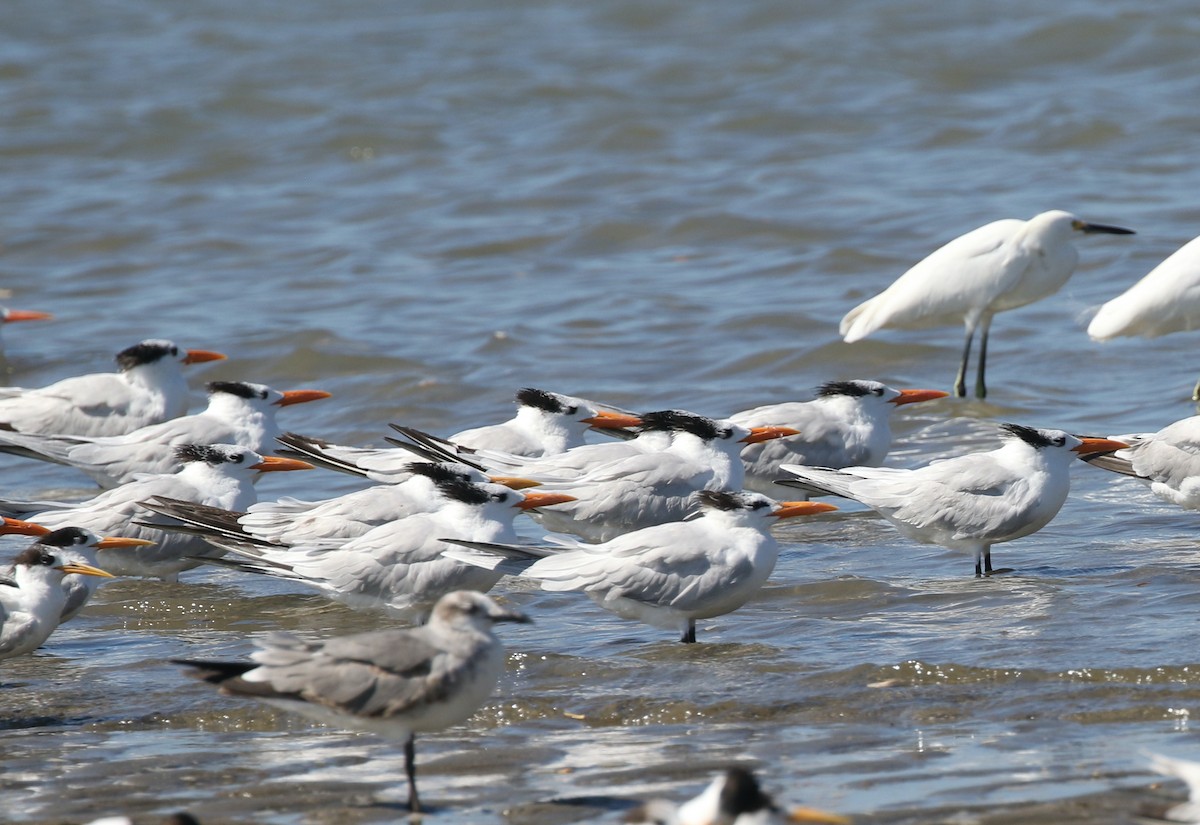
[0,339,226,435]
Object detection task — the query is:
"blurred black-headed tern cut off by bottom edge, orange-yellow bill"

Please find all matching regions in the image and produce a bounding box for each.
[625,767,850,825]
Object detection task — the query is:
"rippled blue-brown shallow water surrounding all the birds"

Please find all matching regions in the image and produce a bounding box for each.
[0,0,1200,825]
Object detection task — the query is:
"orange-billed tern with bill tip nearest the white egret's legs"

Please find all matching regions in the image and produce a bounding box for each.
[730,380,947,499]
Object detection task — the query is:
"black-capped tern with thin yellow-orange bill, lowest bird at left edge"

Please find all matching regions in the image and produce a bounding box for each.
[0,530,113,658]
